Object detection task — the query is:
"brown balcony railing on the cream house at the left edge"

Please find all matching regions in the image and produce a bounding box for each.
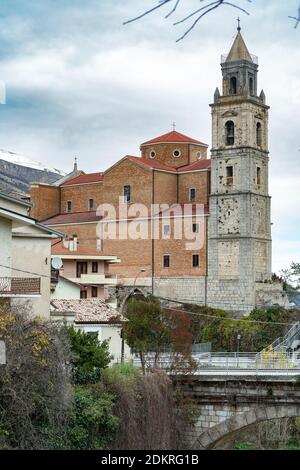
[0,277,41,297]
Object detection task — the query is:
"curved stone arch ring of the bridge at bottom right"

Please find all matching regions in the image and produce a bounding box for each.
[192,405,300,450]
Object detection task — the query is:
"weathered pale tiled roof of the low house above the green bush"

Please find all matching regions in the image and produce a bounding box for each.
[51,299,126,324]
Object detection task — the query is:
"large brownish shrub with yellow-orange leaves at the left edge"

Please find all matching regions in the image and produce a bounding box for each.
[0,307,72,449]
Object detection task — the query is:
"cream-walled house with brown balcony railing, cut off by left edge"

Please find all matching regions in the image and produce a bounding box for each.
[0,192,64,319]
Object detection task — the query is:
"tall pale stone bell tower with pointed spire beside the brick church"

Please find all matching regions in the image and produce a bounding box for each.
[207,24,272,314]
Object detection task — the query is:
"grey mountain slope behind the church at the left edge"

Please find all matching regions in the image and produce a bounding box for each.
[0,159,62,194]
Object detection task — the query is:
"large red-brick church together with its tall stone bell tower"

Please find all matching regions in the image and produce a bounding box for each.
[31,27,284,314]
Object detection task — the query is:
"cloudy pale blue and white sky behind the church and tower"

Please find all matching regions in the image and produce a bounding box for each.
[0,0,300,272]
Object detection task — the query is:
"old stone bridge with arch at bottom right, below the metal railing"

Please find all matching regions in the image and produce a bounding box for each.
[181,374,300,450]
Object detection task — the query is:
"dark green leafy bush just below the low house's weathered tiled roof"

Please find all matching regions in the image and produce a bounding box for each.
[67,327,113,384]
